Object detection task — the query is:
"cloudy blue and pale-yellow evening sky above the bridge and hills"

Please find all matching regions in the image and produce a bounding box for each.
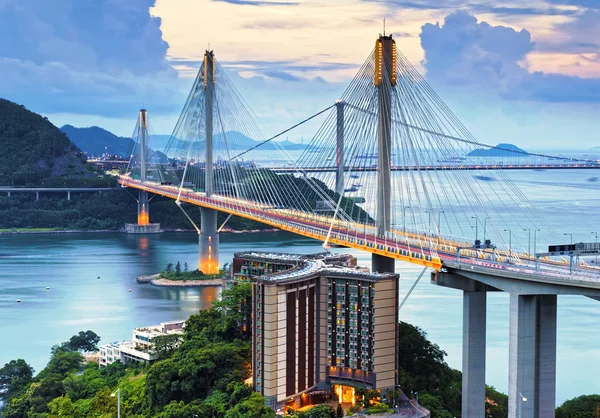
[0,0,600,150]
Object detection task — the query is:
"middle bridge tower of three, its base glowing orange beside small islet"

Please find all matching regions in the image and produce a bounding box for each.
[198,51,219,274]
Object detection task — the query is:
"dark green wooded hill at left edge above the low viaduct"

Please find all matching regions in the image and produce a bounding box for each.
[0,99,93,186]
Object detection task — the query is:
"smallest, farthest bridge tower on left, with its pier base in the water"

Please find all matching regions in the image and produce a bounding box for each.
[125,109,161,234]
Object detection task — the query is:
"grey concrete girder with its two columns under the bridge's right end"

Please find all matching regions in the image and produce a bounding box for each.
[431,269,600,418]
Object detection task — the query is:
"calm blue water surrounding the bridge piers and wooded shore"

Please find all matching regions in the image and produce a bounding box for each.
[0,170,600,403]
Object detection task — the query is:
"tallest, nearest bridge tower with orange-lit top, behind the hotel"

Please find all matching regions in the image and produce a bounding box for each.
[371,35,396,273]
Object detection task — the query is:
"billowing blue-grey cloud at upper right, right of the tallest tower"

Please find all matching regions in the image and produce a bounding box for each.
[421,11,600,102]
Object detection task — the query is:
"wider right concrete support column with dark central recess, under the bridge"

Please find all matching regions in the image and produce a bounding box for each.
[508,294,557,418]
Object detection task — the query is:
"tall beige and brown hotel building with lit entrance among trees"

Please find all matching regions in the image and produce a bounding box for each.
[234,253,398,408]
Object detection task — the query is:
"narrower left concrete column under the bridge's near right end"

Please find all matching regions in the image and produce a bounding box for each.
[462,291,487,418]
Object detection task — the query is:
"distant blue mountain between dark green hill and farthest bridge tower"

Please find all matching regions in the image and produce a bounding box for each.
[60,125,133,157]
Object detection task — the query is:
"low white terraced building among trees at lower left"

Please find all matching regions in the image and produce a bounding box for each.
[98,321,185,367]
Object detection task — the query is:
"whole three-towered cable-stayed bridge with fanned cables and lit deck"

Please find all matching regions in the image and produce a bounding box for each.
[119,36,600,417]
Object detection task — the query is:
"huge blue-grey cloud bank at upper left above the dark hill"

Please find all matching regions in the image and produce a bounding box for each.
[0,0,182,116]
